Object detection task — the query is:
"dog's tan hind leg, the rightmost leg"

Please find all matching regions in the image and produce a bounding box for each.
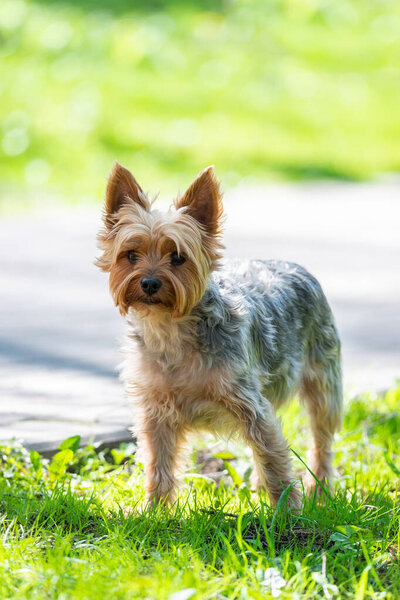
[300,339,343,496]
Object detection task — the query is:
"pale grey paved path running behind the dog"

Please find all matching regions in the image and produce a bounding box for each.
[0,181,400,450]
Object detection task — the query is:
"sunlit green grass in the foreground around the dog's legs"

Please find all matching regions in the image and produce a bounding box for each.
[0,388,400,600]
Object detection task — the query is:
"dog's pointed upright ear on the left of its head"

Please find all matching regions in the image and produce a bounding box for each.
[104,161,148,228]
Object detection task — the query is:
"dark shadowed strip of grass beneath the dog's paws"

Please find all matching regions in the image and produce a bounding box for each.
[0,485,390,561]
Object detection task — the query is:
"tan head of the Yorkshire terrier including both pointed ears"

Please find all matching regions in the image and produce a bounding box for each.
[96,163,222,318]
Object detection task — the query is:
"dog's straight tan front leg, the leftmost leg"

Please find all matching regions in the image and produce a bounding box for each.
[135,415,184,504]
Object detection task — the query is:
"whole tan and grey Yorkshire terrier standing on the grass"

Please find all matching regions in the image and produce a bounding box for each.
[96,163,342,507]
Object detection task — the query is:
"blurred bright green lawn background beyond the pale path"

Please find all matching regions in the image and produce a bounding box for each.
[0,0,400,206]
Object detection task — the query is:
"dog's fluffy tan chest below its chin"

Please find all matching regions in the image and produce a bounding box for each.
[124,312,244,428]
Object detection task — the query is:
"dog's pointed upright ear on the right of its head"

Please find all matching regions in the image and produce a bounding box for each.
[175,166,223,235]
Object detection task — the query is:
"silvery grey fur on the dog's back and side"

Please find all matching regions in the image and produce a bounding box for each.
[194,260,341,404]
